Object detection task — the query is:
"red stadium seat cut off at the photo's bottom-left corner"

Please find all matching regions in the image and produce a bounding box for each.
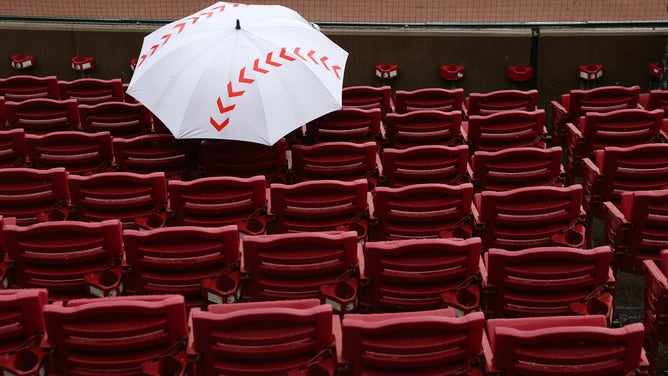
[0,289,48,375]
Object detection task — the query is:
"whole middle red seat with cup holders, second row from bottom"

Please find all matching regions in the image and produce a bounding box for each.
[204,231,361,313]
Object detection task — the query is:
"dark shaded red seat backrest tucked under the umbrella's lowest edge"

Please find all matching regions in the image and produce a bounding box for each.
[201,139,288,184]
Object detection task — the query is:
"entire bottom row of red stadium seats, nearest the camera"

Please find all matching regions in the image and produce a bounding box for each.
[0,289,649,376]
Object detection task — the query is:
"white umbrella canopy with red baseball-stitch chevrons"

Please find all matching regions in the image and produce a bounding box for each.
[127,2,348,145]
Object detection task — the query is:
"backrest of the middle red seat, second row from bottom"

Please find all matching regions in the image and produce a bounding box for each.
[241,231,358,301]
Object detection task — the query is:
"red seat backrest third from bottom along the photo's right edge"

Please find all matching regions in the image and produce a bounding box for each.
[583,144,668,210]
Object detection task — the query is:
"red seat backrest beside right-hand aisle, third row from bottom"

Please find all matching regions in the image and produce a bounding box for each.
[474,184,586,250]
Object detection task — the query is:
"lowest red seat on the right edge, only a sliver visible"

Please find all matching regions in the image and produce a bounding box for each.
[643,249,668,374]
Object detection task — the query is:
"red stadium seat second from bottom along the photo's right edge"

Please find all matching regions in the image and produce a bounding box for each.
[603,189,668,274]
